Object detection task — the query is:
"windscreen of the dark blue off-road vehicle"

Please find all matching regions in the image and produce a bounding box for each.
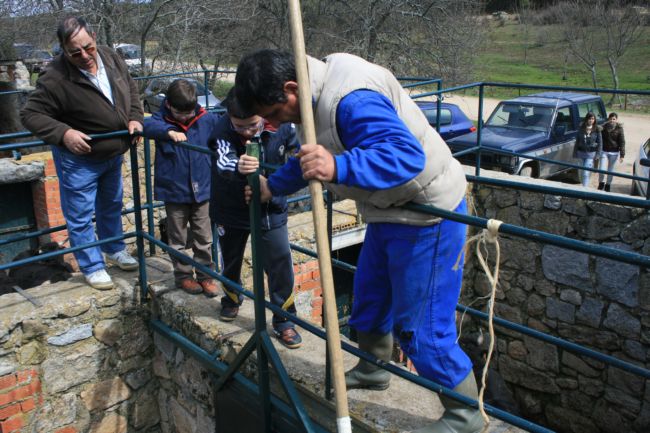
[486,102,553,131]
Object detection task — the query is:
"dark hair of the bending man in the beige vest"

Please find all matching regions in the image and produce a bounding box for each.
[235,49,297,111]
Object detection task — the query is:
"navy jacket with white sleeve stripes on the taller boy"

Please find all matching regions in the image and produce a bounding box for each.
[210,115,300,230]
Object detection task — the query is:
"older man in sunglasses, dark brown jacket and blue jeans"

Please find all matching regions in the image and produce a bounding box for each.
[21,17,144,290]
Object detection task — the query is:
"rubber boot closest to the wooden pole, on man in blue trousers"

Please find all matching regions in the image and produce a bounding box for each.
[345,332,393,391]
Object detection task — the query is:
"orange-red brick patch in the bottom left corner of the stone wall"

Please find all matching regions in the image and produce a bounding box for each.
[0,369,42,433]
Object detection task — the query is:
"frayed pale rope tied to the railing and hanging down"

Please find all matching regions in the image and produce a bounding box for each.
[454,219,503,432]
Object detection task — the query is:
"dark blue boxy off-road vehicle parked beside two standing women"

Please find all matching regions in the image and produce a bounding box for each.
[447,92,607,178]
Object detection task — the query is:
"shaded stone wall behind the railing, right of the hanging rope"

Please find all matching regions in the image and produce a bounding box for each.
[461,172,650,433]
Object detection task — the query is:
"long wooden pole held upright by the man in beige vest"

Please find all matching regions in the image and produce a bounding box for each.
[289,0,352,433]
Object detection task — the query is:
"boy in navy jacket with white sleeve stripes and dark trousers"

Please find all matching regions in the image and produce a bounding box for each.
[210,89,302,349]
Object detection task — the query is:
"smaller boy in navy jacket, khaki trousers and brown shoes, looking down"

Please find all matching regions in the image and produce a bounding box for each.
[144,79,219,297]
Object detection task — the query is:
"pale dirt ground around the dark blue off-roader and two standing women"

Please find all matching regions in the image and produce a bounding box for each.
[438,95,650,194]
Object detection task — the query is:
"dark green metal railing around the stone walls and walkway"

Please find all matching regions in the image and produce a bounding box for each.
[0,73,650,432]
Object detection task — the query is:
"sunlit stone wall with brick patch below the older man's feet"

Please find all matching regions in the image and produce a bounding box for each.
[0,270,160,433]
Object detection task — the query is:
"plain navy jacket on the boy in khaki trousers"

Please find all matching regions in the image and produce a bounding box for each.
[143,104,219,204]
